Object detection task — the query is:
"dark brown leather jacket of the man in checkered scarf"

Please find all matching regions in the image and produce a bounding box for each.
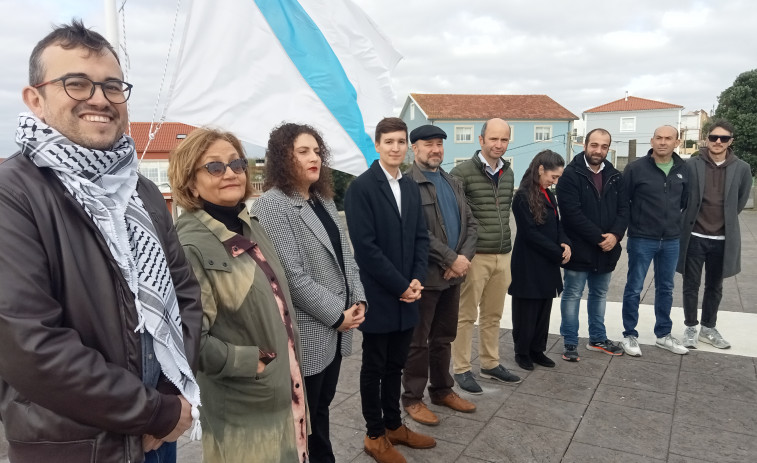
[0,155,202,463]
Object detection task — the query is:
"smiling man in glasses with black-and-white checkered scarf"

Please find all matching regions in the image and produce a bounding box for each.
[0,21,202,462]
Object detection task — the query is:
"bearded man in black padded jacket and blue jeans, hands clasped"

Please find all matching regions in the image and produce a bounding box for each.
[557,129,628,362]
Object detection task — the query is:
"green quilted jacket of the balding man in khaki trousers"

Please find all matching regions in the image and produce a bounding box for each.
[450,151,515,254]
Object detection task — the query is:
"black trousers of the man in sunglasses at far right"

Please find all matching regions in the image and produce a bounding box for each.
[683,235,725,328]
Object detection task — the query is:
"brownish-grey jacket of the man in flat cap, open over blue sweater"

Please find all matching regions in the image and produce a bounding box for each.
[405,162,478,290]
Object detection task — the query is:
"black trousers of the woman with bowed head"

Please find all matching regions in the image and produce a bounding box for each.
[512,297,552,356]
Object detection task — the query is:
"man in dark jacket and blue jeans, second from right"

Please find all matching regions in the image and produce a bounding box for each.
[621,125,689,357]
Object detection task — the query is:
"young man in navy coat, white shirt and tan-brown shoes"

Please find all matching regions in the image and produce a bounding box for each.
[344,117,436,462]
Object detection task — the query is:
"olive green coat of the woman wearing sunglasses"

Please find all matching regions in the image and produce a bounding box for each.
[176,209,304,463]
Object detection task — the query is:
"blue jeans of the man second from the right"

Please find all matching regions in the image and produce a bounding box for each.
[623,237,679,338]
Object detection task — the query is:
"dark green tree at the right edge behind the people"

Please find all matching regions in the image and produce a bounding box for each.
[716,69,757,176]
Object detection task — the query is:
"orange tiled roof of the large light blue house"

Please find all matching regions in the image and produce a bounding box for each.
[410,93,578,120]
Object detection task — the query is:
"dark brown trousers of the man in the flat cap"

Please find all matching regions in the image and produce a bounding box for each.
[402,285,460,407]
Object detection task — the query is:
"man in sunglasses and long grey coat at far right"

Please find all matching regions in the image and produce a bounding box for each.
[676,120,752,349]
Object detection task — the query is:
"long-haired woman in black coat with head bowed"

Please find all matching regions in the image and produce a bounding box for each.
[508,150,570,370]
